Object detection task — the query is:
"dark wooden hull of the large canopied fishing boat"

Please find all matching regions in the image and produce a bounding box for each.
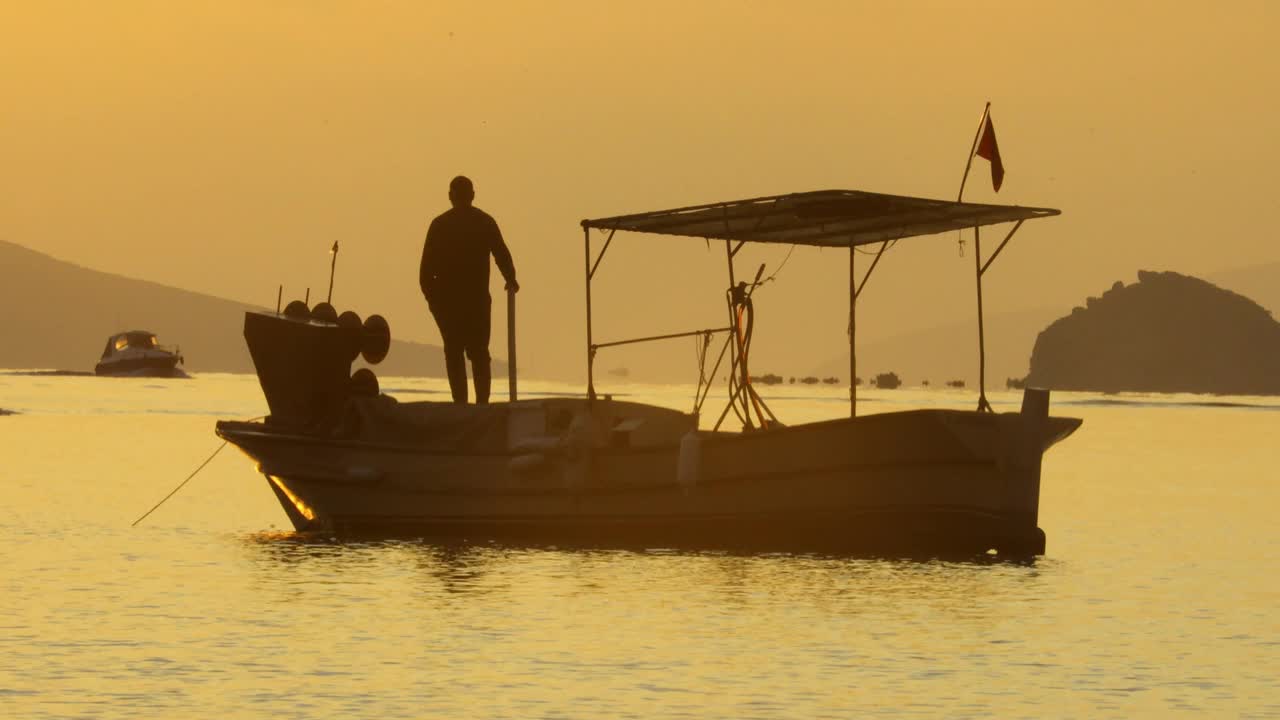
[218,410,1080,553]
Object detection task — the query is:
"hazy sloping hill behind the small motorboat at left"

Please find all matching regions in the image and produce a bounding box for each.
[0,241,481,377]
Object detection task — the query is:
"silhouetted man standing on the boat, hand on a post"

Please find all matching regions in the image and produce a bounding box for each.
[419,176,520,405]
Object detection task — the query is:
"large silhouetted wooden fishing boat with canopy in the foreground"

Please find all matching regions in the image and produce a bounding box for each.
[216,190,1080,556]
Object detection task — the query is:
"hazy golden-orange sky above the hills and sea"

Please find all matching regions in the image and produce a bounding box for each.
[0,0,1280,379]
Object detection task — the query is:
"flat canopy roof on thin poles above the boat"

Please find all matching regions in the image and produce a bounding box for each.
[582,190,1060,247]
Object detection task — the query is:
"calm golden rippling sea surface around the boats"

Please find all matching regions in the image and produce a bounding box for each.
[0,374,1280,719]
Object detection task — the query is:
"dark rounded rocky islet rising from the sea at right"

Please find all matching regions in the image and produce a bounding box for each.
[1027,270,1280,395]
